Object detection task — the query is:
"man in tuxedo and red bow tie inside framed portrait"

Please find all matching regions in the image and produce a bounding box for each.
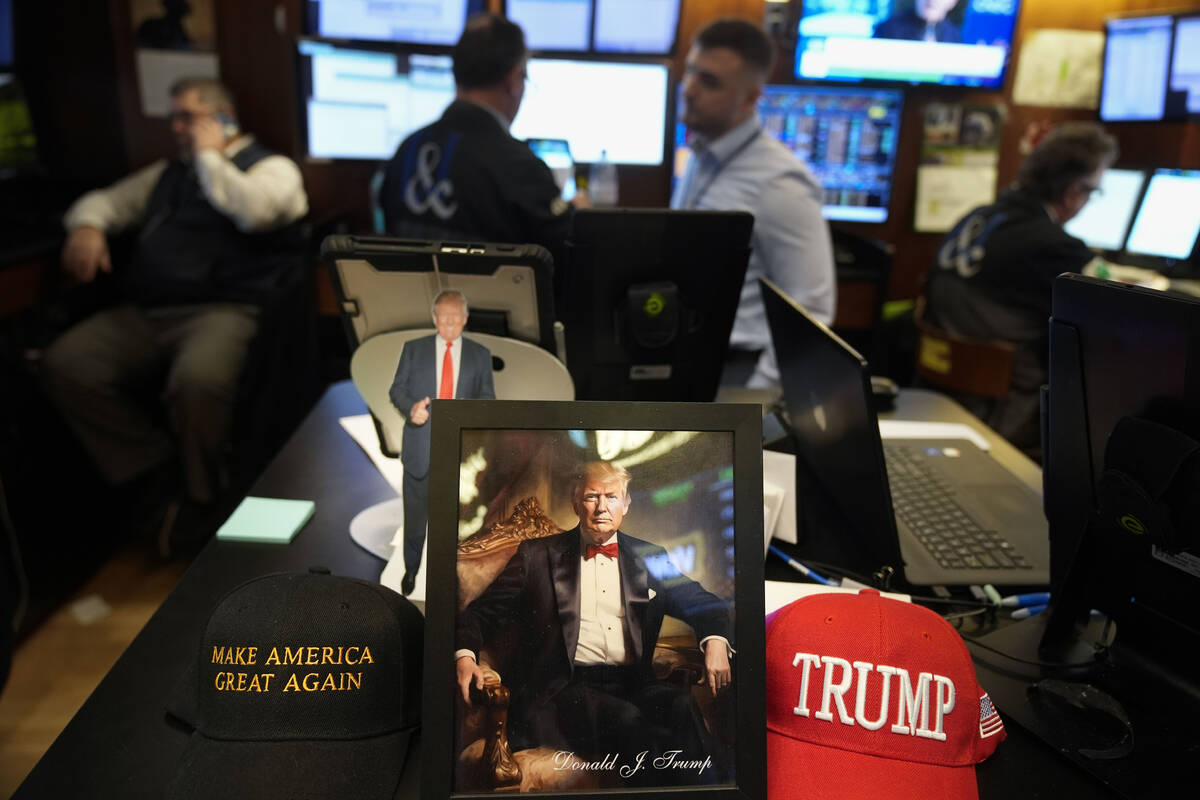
[455,462,732,786]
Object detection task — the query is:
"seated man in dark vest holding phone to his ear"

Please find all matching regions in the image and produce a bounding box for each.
[43,78,308,551]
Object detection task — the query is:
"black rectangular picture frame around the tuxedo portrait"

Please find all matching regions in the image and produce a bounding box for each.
[421,401,767,800]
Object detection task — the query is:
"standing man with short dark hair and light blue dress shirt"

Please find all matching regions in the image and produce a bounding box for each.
[671,19,836,386]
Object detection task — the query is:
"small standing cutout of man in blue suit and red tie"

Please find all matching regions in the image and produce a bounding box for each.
[388,289,496,595]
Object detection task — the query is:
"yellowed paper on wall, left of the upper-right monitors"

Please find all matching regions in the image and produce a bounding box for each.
[1013,29,1104,108]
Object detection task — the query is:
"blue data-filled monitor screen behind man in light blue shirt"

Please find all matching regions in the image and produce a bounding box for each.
[674,85,904,222]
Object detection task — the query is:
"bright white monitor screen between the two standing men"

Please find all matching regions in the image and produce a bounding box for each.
[511,59,667,166]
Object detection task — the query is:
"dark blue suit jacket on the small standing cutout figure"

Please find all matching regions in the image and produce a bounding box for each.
[388,333,496,477]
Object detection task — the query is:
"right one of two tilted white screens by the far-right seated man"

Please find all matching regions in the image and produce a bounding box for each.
[1126,169,1200,259]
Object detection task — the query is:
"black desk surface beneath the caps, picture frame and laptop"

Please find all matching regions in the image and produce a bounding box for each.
[13,381,1102,800]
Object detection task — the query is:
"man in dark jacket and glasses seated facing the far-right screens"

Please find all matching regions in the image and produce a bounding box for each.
[925,122,1117,455]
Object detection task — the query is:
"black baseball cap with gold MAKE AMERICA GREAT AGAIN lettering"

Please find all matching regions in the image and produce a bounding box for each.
[167,571,425,800]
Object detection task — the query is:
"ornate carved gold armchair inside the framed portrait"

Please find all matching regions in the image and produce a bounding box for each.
[456,497,732,792]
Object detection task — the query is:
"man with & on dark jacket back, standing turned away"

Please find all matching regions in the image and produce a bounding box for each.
[379,13,587,268]
